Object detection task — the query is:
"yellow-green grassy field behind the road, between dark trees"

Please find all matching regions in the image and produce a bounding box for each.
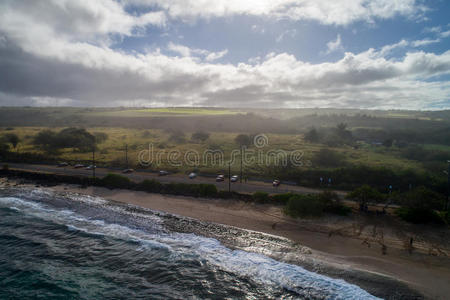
[0,127,422,173]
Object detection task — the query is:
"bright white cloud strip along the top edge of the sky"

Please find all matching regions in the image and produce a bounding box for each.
[124,0,428,25]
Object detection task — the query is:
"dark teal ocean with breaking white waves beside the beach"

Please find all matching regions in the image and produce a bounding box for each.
[0,187,377,299]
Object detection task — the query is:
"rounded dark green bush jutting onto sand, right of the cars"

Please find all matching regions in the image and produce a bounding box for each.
[284,195,325,218]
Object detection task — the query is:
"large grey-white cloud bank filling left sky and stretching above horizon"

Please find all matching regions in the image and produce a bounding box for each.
[0,0,450,109]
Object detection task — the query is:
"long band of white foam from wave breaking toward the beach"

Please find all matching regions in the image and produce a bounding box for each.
[0,193,377,300]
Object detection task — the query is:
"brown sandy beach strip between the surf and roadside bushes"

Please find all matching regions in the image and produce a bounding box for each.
[1,181,450,299]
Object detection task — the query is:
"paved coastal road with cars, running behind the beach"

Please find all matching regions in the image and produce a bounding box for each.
[3,163,345,195]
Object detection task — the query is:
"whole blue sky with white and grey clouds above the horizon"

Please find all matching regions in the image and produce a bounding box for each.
[0,0,450,110]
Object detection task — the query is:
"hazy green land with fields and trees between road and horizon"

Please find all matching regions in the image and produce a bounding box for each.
[0,107,450,209]
